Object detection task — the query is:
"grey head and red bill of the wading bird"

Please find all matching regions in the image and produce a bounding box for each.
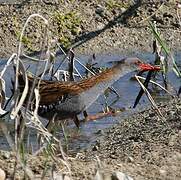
[123,58,160,71]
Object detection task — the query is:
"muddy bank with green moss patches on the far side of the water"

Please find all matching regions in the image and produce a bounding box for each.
[0,0,181,57]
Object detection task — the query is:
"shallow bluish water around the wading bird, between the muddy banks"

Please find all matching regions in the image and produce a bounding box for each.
[0,53,181,152]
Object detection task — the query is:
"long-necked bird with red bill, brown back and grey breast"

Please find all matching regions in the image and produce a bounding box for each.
[19,57,160,126]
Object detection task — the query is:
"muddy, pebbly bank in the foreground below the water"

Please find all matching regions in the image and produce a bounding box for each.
[0,99,181,180]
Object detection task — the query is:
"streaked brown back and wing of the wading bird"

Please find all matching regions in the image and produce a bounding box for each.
[19,69,113,105]
